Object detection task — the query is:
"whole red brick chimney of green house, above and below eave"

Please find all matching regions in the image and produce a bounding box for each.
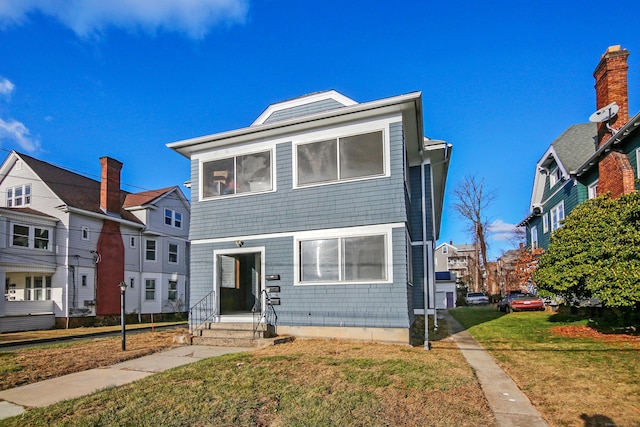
[593,45,635,197]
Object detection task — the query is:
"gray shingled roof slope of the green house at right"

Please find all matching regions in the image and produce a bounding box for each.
[551,123,597,172]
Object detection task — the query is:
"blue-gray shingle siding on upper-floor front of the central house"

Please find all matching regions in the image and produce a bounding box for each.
[190,123,407,240]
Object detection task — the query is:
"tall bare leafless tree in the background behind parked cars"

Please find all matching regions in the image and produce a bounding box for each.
[453,175,495,289]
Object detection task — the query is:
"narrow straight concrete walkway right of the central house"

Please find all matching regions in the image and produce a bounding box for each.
[438,311,548,427]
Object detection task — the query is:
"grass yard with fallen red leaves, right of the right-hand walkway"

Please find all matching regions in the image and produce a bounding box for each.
[451,307,640,426]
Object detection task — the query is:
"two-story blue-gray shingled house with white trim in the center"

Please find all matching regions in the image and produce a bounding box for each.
[168,91,451,343]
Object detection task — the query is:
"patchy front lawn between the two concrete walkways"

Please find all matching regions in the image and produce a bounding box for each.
[0,339,495,427]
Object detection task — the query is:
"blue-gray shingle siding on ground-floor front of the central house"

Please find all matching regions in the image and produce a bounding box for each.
[191,228,412,328]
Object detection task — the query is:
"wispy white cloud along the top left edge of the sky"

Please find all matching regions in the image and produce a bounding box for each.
[0,0,249,39]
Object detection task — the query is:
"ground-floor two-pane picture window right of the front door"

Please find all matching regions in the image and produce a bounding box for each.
[300,235,387,283]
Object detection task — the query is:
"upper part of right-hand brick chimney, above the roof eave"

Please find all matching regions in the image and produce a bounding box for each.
[593,45,629,147]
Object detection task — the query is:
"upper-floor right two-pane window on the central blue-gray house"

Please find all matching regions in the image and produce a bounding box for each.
[296,131,384,185]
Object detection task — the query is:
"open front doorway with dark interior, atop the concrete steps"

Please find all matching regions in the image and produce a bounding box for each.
[217,251,262,318]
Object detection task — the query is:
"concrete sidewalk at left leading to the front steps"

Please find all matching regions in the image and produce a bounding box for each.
[0,345,252,420]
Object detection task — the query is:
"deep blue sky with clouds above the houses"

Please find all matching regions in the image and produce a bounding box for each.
[0,0,640,257]
